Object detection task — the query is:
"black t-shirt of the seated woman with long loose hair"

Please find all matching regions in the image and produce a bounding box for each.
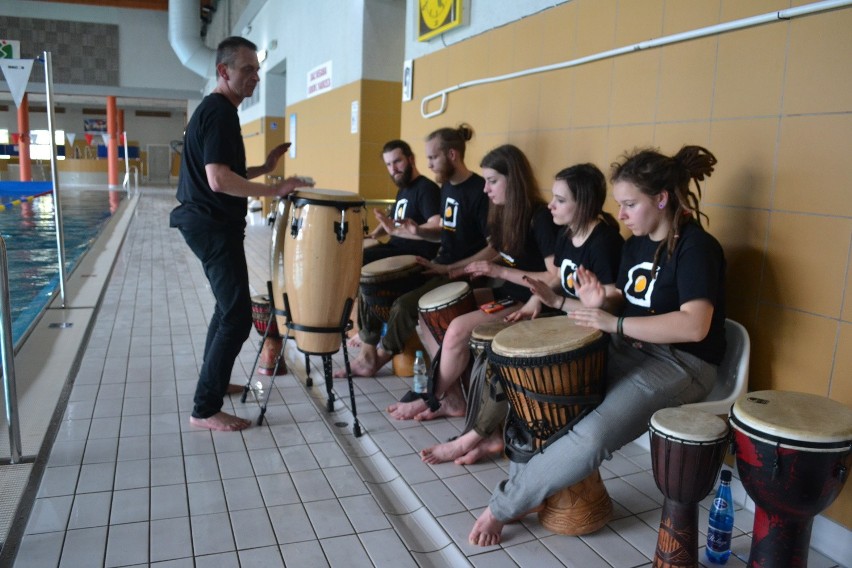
[494,205,558,302]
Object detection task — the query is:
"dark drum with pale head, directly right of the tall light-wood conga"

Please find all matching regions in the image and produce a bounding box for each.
[361,254,423,322]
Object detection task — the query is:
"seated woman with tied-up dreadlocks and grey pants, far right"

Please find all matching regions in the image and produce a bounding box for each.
[468,146,725,546]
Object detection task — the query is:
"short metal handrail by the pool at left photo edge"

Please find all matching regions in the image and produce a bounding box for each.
[0,237,21,464]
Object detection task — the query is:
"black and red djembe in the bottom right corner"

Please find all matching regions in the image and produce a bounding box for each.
[730,390,852,568]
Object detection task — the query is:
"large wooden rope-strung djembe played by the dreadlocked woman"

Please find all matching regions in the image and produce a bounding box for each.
[488,317,612,535]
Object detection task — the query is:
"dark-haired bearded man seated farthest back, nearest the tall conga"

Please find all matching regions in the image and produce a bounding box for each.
[364,140,441,264]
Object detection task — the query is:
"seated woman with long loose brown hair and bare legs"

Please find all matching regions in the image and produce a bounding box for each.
[388,144,556,420]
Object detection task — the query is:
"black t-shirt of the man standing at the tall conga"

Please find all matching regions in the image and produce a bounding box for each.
[170,93,246,230]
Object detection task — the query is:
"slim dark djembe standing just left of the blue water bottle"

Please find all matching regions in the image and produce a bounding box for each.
[648,408,730,568]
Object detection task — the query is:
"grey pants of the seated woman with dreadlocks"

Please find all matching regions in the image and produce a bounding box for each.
[489,336,716,522]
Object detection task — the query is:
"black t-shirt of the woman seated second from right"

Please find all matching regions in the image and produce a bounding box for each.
[553,222,624,298]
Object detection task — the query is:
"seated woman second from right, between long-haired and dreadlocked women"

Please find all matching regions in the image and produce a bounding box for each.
[420,164,624,464]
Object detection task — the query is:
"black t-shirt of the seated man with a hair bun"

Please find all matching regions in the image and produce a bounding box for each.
[435,174,488,264]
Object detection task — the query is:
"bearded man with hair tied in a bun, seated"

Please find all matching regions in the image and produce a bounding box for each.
[342,124,497,390]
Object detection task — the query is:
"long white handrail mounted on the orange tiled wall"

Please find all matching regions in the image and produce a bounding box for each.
[420,0,852,118]
